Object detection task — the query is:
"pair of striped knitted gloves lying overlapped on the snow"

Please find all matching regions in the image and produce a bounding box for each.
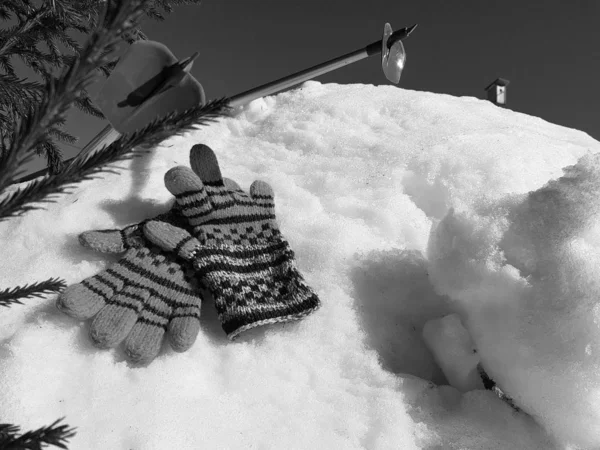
[56,144,320,364]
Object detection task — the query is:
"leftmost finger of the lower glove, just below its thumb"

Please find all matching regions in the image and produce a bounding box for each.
[56,263,123,320]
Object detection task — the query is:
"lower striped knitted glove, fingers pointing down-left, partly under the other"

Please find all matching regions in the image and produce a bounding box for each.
[56,202,202,364]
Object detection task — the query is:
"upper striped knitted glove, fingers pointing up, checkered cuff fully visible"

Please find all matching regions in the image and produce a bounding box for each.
[144,144,320,339]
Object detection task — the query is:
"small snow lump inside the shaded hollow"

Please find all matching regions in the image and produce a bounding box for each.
[423,314,483,392]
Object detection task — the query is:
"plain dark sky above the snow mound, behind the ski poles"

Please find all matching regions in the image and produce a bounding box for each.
[12,0,600,178]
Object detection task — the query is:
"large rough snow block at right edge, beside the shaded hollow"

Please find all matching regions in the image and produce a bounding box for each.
[428,153,600,449]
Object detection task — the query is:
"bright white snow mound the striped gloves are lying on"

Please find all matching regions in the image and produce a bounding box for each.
[0,81,600,450]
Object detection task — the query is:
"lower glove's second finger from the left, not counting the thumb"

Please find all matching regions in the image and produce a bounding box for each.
[90,286,150,348]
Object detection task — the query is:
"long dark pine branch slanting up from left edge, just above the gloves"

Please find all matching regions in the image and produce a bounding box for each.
[0,99,229,222]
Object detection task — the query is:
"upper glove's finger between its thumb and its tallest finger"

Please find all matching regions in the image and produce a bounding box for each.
[165,166,213,227]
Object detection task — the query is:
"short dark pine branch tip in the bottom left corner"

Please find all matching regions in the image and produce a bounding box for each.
[0,417,76,450]
